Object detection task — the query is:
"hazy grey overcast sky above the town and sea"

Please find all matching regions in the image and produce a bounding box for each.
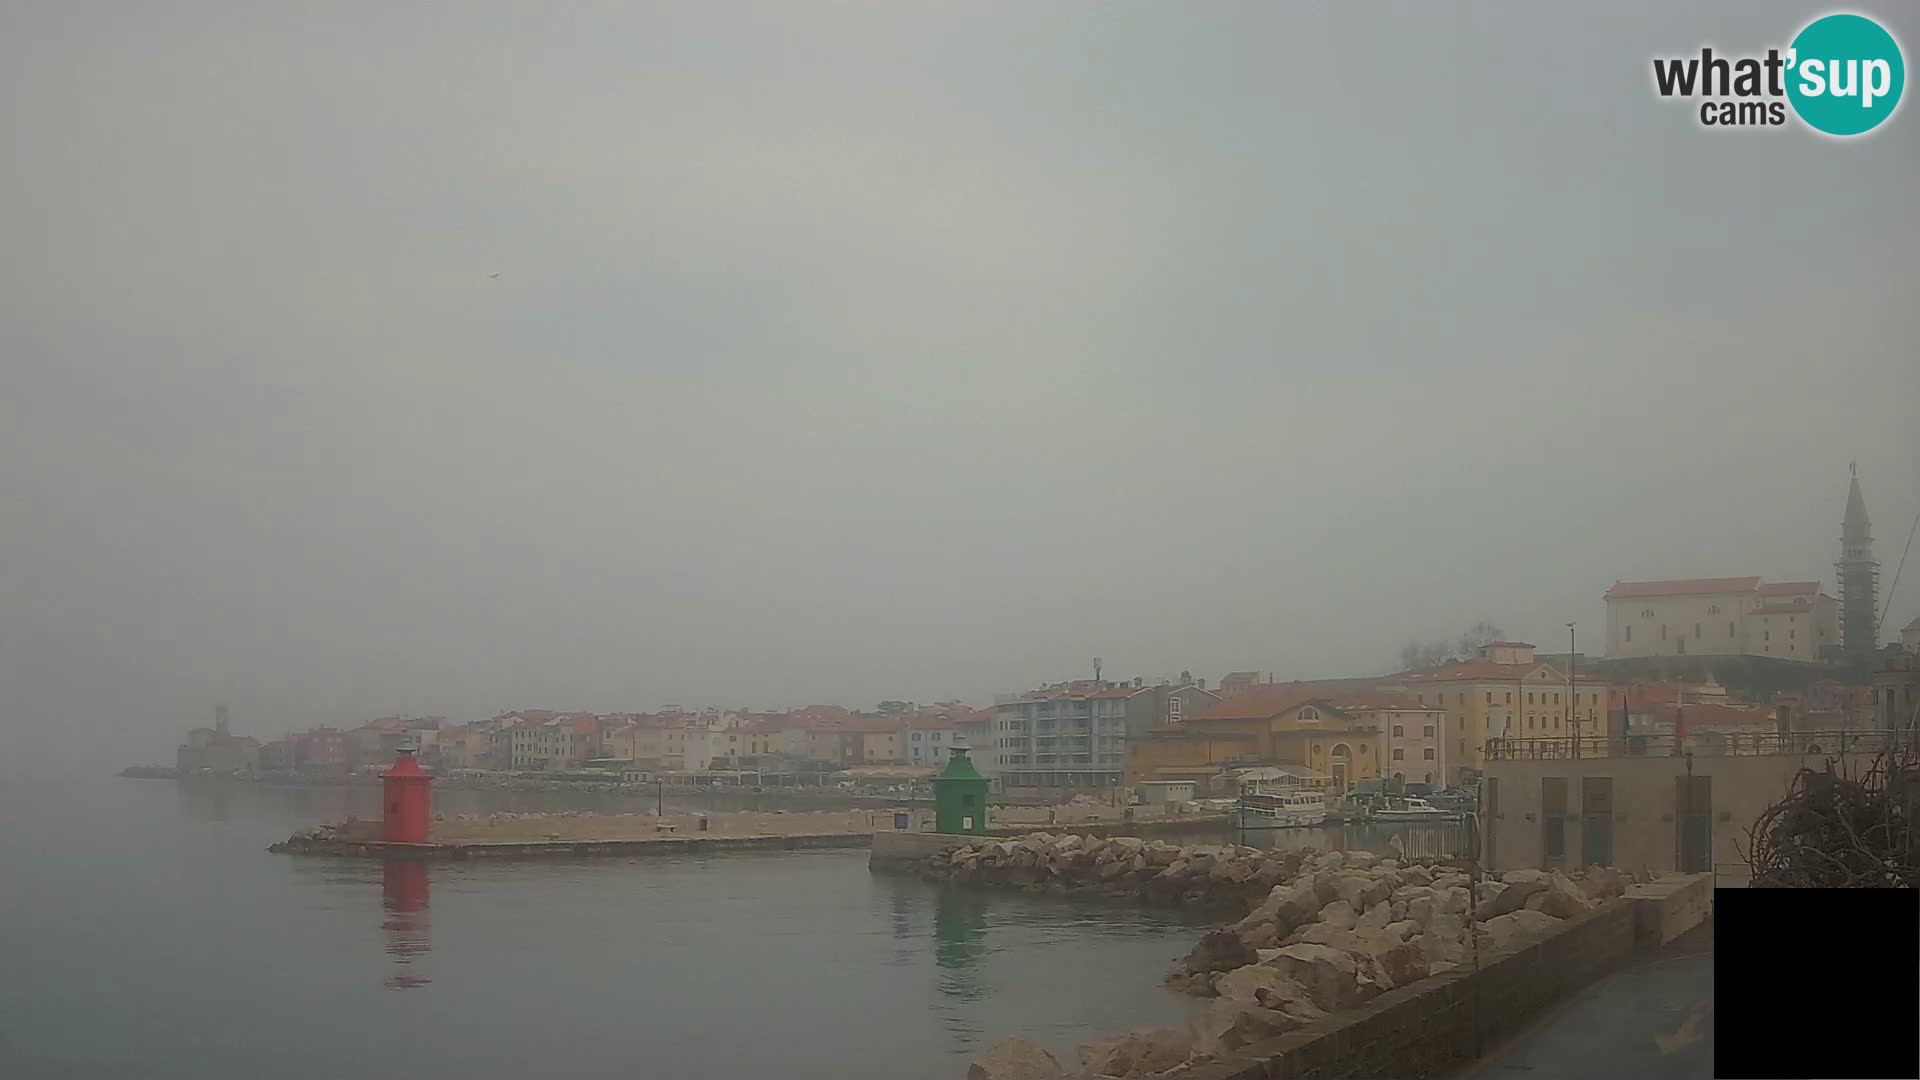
[0,0,1920,765]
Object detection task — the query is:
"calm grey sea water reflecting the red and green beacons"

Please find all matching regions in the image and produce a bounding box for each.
[0,776,1228,1080]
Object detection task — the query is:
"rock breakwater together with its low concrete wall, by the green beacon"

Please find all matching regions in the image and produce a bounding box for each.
[874,832,1713,1080]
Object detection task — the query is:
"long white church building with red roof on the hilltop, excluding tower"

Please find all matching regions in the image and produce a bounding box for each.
[1605,577,1839,663]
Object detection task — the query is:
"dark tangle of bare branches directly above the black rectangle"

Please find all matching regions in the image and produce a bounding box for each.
[1747,748,1920,888]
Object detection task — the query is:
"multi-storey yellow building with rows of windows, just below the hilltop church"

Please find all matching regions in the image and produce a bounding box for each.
[1390,642,1611,784]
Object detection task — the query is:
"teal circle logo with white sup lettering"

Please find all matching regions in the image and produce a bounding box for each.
[1788,15,1907,136]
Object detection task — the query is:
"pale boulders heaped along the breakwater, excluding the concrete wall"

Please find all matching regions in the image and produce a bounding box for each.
[956,832,1645,1080]
